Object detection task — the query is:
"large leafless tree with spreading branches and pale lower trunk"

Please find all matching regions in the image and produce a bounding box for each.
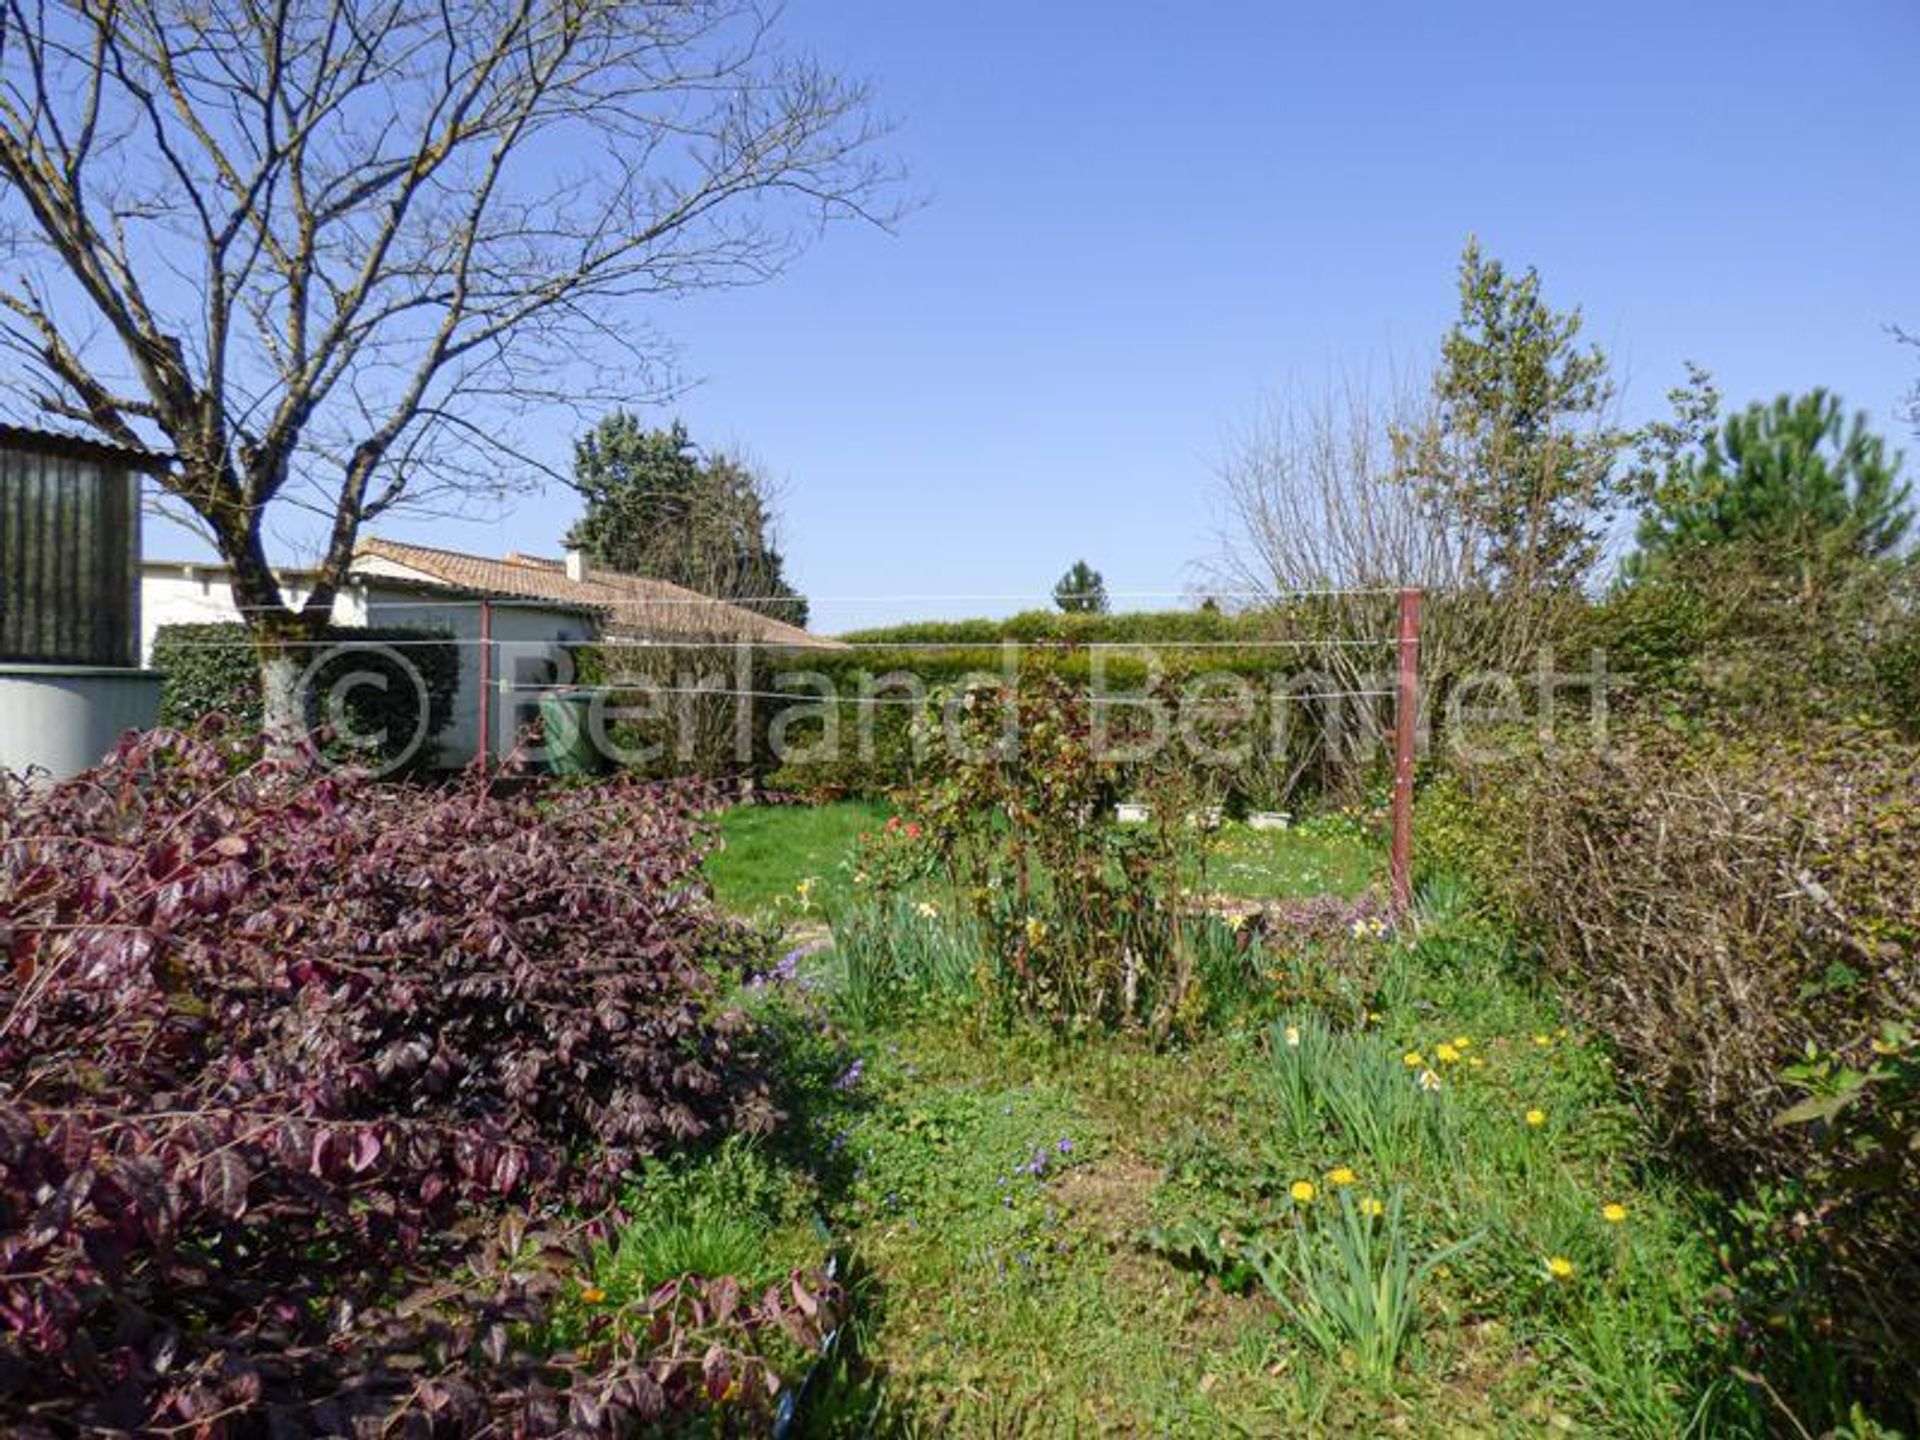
[0,0,895,726]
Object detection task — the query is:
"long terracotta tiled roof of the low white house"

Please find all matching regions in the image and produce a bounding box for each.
[353,538,839,649]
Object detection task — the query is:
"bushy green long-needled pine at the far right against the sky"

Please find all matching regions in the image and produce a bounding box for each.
[1628,390,1912,589]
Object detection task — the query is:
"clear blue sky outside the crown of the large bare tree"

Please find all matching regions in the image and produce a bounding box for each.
[353,0,1920,630]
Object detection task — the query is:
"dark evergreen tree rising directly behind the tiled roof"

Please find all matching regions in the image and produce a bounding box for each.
[566,411,806,626]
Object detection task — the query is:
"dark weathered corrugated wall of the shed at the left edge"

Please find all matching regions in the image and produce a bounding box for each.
[0,447,140,664]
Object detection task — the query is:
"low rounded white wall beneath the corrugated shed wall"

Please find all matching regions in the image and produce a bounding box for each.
[0,664,159,780]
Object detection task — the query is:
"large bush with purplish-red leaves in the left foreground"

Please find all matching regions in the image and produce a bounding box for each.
[0,732,831,1436]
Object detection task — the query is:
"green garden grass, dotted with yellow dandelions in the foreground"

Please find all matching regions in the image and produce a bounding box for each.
[656,806,1764,1436]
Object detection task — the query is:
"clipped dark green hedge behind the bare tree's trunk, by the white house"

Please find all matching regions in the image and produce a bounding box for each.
[154,622,461,768]
